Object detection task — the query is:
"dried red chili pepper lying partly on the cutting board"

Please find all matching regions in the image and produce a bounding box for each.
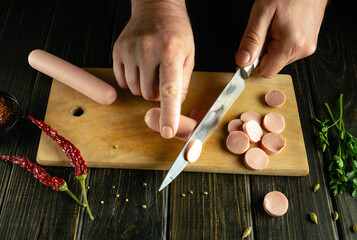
[27,116,94,220]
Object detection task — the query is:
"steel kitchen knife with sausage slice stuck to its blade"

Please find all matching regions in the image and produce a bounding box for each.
[159,57,260,191]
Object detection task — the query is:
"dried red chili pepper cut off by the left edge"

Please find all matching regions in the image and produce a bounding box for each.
[0,155,84,207]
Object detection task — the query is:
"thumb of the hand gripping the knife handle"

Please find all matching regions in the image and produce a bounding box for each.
[236,1,275,67]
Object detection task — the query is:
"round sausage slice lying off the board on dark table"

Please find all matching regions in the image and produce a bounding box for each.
[263,191,289,217]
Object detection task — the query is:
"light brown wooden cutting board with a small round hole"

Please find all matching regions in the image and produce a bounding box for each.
[37,68,309,176]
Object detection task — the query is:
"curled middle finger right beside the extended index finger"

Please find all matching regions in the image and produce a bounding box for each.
[140,63,160,101]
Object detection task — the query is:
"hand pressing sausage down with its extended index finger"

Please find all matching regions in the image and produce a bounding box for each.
[113,0,195,138]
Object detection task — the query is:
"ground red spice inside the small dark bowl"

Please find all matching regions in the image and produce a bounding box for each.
[0,97,19,132]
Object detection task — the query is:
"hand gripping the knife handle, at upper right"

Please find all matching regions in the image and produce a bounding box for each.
[236,0,327,78]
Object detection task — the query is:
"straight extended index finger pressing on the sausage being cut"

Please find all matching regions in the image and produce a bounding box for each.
[159,60,184,138]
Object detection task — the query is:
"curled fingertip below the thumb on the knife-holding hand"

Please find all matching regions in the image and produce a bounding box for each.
[258,39,291,78]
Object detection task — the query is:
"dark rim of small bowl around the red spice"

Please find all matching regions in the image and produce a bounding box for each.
[0,90,23,144]
